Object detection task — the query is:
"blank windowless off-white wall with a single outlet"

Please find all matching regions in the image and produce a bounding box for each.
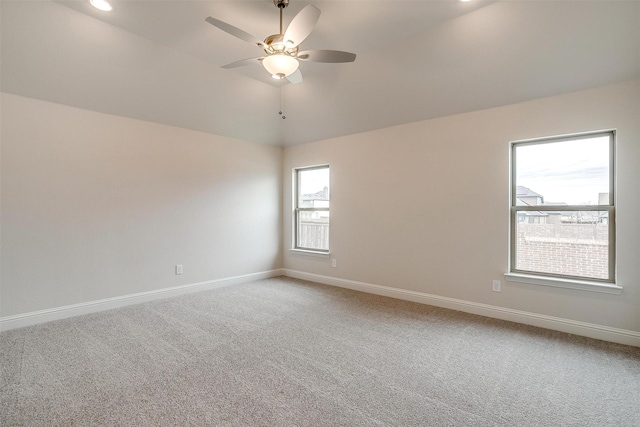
[0,93,282,317]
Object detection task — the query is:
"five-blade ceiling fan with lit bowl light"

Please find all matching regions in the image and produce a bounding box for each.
[206,0,356,83]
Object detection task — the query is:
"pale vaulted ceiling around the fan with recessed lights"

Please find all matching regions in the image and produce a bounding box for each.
[0,0,640,146]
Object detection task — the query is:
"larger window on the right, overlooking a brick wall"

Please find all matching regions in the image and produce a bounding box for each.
[507,131,621,290]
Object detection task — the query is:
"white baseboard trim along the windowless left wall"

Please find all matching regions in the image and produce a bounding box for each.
[0,268,283,332]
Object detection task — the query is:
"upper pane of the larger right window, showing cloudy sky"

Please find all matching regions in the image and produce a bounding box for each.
[515,136,610,206]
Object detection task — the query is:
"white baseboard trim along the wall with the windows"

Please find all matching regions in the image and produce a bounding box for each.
[282,268,640,347]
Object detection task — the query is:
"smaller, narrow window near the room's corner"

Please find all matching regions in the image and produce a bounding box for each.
[294,166,329,253]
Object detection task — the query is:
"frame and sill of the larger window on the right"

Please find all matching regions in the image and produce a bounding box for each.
[505,129,622,294]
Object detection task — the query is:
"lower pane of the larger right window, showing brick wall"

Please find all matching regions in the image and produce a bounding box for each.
[515,211,609,280]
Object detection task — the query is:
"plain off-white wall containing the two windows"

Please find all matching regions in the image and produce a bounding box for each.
[283,81,640,331]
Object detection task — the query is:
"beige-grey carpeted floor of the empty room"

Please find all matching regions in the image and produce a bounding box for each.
[0,277,640,427]
